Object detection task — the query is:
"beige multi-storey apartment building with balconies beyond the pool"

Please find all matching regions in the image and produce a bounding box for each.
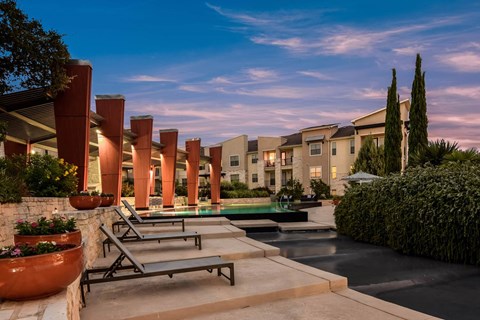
[214,100,410,195]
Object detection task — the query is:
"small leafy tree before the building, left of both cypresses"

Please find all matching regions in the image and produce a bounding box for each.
[352,136,384,176]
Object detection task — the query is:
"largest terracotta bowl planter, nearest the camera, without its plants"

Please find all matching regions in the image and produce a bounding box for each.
[0,246,83,300]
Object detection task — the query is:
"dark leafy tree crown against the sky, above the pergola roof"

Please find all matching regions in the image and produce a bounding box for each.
[0,0,70,96]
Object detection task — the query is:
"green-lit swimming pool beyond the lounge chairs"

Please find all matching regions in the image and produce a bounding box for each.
[150,203,308,222]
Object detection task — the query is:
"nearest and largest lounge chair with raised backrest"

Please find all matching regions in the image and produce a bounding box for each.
[80,225,235,305]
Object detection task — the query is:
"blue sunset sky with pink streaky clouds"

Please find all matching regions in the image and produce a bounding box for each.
[18,0,480,148]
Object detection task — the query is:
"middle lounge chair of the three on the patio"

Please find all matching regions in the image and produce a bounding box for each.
[103,208,202,257]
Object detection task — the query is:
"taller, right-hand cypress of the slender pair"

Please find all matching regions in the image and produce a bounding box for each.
[408,54,428,162]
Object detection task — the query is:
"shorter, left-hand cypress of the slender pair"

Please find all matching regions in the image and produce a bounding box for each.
[384,69,402,175]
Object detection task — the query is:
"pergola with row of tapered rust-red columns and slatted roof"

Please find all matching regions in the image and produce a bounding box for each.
[0,60,221,209]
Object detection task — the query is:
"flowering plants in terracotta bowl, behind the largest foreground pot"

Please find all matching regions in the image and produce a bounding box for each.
[13,217,82,246]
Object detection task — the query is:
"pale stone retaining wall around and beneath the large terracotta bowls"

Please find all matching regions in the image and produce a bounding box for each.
[0,198,118,320]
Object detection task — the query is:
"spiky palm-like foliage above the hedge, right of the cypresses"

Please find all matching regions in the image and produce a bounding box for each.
[410,139,458,166]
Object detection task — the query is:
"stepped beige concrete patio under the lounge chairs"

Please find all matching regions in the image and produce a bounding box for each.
[80,207,436,320]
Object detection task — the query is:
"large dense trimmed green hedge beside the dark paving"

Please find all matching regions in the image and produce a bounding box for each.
[335,164,480,265]
